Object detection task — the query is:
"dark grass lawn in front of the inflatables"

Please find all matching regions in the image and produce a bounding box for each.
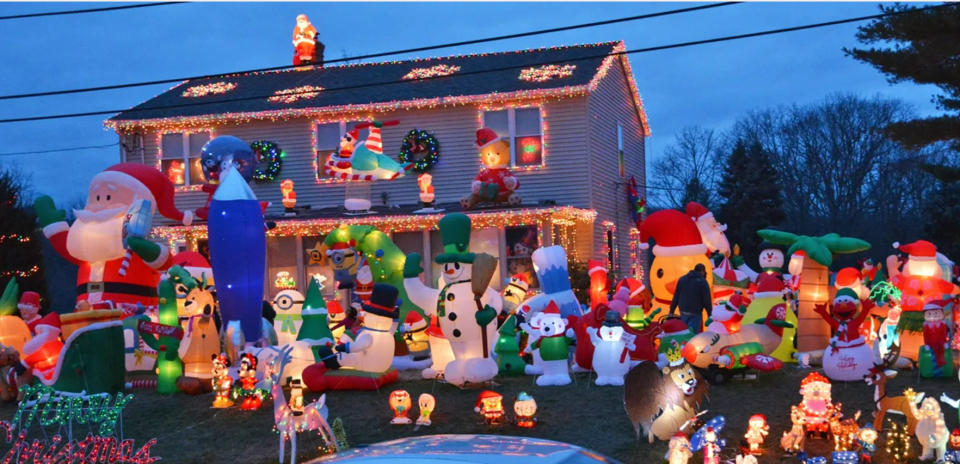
[0,365,960,464]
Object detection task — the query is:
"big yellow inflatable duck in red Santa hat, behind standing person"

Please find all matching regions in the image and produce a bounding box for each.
[640,209,713,320]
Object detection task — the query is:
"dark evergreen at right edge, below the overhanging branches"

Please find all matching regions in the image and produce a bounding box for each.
[922,182,960,256]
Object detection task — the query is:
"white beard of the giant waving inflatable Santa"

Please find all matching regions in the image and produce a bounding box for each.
[67,208,126,263]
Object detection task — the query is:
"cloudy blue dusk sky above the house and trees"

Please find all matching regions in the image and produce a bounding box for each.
[0,2,936,202]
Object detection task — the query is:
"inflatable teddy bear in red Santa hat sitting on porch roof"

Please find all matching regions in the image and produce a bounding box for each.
[460,127,521,209]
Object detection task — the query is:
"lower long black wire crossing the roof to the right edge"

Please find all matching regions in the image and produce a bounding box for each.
[0,4,953,124]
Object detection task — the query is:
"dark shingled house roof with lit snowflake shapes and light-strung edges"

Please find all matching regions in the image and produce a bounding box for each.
[105,42,649,133]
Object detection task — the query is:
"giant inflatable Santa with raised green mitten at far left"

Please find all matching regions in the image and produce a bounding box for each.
[34,163,193,309]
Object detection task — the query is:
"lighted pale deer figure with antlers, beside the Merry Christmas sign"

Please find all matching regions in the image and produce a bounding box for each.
[270,346,334,464]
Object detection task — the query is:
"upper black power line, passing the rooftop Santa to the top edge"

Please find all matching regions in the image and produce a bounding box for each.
[0,2,743,100]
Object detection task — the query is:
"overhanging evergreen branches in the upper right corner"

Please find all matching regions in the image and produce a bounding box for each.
[844,3,960,176]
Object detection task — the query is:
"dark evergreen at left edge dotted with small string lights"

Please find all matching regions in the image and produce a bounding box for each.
[0,168,47,307]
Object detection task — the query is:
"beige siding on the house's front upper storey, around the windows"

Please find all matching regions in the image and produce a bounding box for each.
[144,98,592,223]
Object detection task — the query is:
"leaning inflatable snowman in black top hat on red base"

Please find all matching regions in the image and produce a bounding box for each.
[319,284,400,373]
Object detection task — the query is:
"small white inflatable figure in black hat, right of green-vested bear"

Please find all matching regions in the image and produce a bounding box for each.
[590,311,635,386]
